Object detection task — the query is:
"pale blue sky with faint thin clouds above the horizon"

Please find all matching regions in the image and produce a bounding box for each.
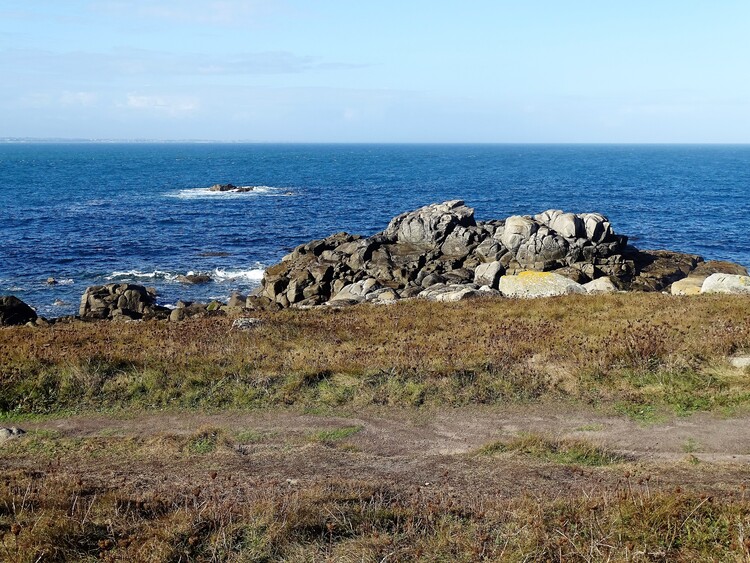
[0,0,750,143]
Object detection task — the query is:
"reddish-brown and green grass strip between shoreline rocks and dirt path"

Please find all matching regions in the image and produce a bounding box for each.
[0,294,750,422]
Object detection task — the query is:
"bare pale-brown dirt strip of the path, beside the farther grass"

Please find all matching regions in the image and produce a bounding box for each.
[24,406,750,462]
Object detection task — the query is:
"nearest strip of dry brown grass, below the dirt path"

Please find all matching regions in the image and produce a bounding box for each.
[0,464,750,562]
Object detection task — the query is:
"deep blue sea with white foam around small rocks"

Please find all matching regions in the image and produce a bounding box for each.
[0,143,750,316]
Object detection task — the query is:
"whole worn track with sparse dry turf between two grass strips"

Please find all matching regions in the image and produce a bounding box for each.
[0,405,750,498]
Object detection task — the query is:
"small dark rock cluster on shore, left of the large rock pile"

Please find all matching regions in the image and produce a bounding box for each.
[78,283,170,320]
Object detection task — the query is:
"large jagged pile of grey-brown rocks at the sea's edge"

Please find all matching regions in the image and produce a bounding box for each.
[255,200,744,307]
